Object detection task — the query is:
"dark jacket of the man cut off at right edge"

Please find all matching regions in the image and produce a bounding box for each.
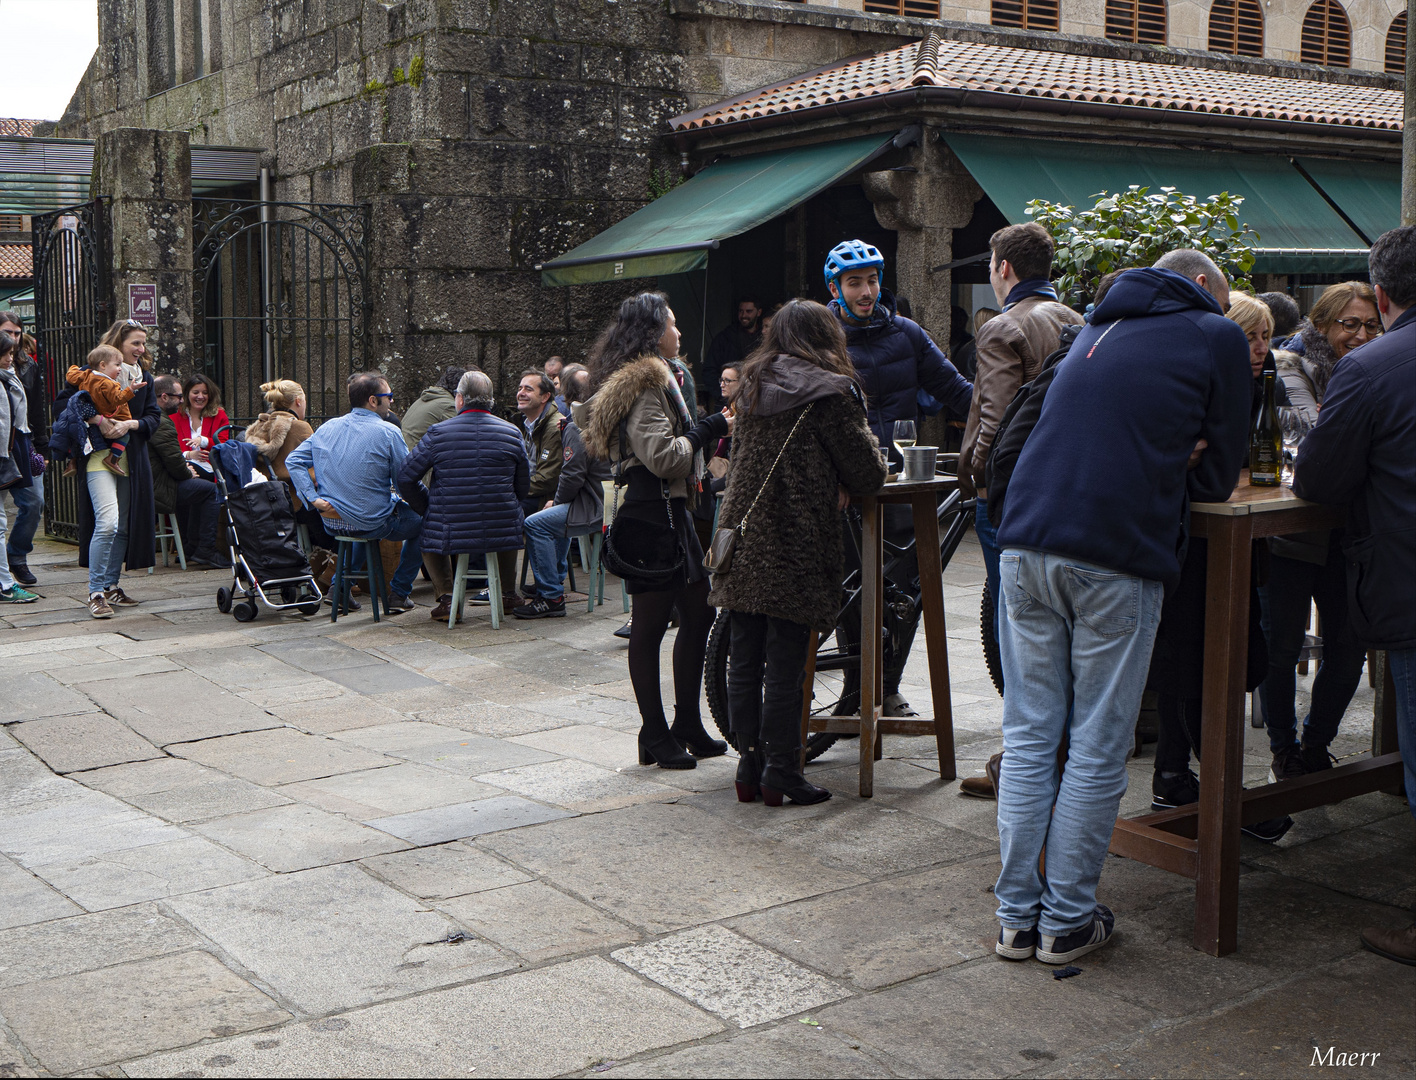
[1293,307,1416,650]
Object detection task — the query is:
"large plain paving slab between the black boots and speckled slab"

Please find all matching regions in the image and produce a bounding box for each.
[479,803,865,933]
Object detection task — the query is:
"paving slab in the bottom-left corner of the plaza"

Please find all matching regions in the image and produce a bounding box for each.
[0,953,289,1073]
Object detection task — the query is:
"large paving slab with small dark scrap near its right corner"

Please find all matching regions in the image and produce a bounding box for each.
[171,866,517,1013]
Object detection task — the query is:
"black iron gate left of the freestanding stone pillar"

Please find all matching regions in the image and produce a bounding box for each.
[31,198,112,541]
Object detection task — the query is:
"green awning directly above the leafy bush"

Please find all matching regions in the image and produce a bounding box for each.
[944,133,1366,273]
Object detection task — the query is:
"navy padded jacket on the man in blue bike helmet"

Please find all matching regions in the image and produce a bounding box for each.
[831,289,973,446]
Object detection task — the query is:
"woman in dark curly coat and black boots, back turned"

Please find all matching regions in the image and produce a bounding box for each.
[708,300,885,807]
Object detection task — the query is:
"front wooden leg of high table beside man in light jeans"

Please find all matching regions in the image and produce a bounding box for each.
[1195,514,1253,957]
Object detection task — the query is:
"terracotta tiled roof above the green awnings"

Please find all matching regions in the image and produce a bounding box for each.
[670,34,1402,132]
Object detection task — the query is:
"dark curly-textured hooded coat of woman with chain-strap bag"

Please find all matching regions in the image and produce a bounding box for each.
[708,357,885,631]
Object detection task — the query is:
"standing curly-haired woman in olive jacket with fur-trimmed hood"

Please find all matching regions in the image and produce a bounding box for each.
[582,293,732,769]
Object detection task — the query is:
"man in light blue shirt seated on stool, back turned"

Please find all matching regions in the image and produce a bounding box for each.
[286,371,423,614]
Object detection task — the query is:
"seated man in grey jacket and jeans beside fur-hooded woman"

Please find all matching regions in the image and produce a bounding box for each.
[511,368,610,619]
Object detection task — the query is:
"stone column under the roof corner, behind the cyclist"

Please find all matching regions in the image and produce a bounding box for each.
[864,129,983,446]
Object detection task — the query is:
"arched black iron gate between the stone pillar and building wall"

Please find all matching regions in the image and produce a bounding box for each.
[191,198,368,425]
